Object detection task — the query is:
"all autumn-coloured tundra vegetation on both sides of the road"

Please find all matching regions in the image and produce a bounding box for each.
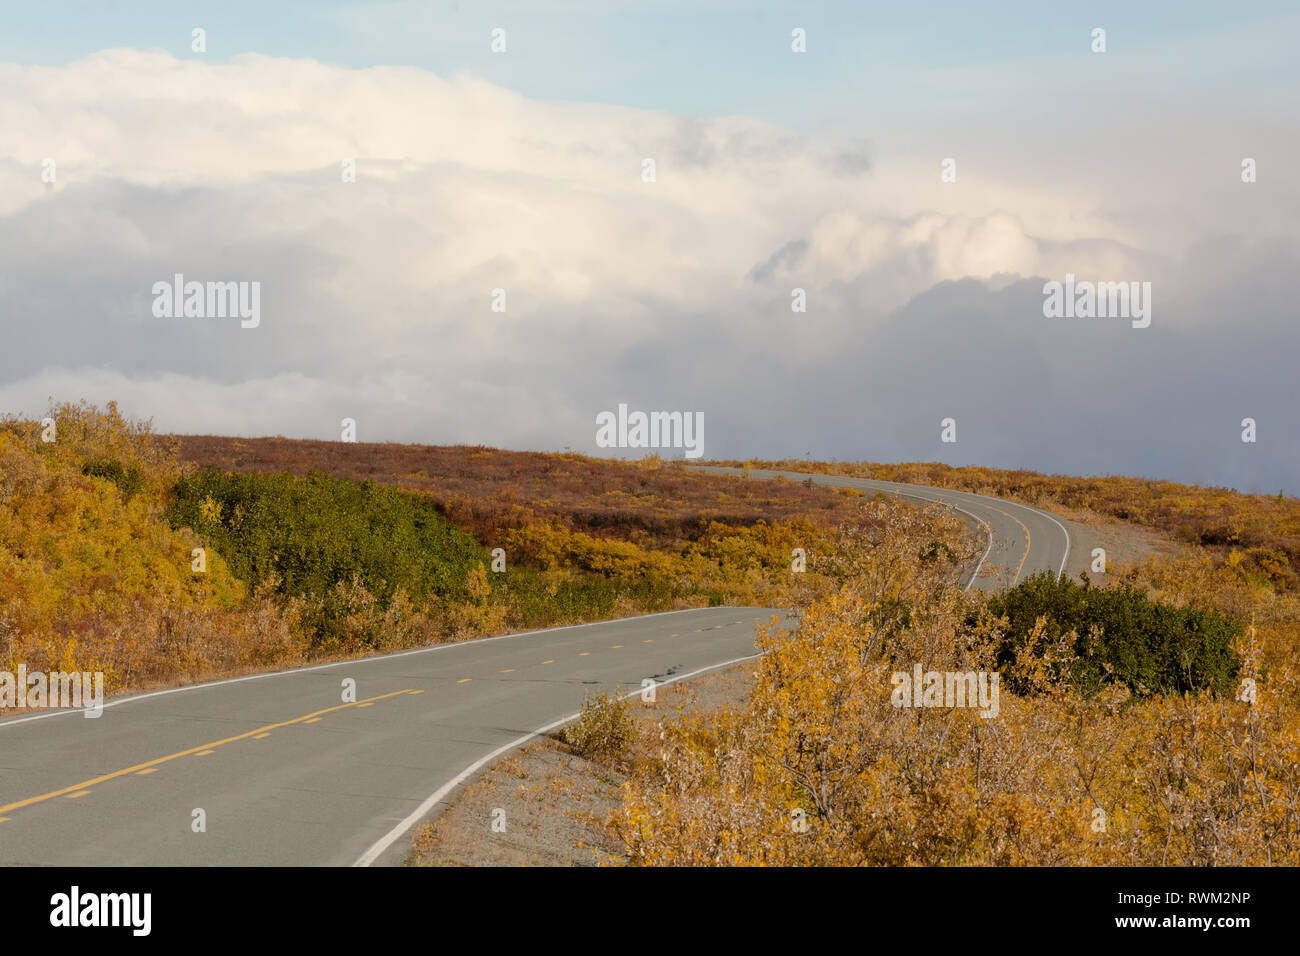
[0,403,1300,865]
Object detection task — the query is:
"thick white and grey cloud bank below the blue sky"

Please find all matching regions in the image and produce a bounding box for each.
[0,49,1300,493]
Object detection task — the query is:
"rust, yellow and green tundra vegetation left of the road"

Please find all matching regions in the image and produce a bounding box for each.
[0,402,832,693]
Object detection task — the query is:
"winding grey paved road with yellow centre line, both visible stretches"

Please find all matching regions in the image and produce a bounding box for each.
[0,472,1065,865]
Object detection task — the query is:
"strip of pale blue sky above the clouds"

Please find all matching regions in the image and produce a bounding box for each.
[10,0,1296,129]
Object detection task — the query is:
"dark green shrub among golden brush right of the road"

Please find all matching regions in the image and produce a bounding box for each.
[988,572,1243,697]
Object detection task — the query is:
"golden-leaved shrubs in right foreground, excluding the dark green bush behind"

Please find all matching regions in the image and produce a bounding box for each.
[614,561,1300,866]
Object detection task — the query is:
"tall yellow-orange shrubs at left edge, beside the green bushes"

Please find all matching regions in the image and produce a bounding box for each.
[0,403,307,693]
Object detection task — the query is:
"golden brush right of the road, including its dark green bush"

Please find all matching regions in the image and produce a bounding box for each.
[611,489,1300,866]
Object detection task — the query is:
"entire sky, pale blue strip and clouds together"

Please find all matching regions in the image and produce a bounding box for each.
[0,0,1300,494]
